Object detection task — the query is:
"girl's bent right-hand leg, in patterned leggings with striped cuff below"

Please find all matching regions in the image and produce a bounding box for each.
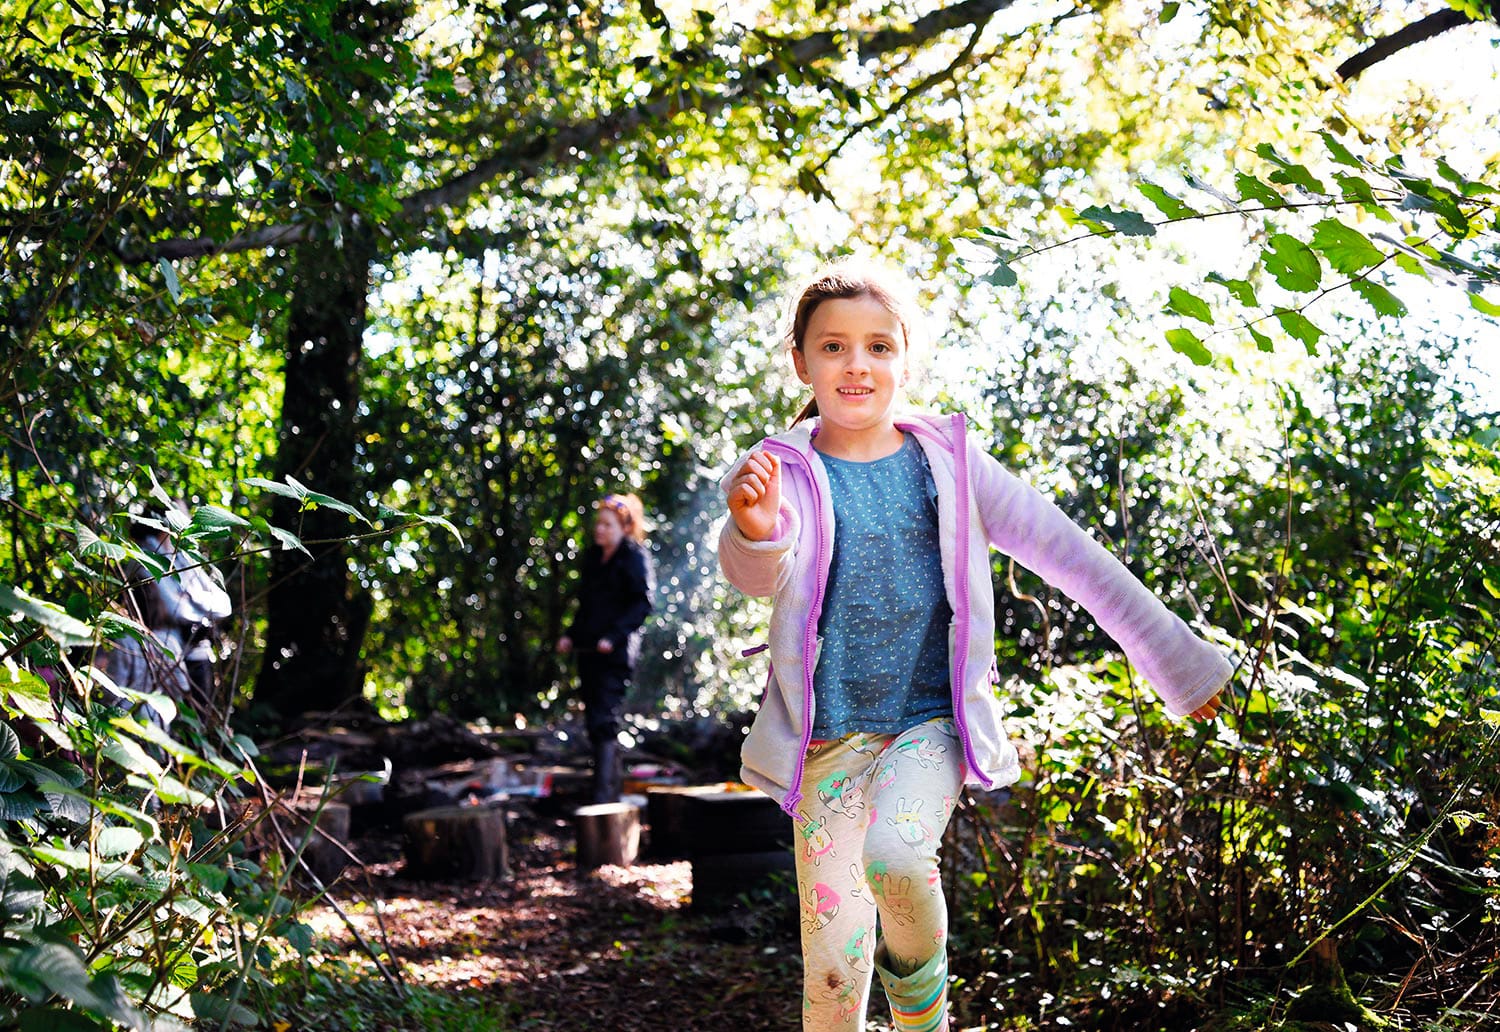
[864,719,963,1032]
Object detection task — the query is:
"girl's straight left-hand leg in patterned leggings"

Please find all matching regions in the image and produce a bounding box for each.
[795,735,885,1032]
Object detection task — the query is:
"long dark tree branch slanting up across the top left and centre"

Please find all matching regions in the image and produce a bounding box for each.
[122,0,1016,264]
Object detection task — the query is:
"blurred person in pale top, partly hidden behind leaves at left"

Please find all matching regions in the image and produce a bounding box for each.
[131,522,234,705]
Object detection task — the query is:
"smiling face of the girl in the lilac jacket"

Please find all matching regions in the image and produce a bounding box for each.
[792,294,906,437]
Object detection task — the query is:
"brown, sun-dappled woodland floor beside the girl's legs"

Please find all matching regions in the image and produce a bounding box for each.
[311,813,906,1032]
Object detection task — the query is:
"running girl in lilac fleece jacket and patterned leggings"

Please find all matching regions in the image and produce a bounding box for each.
[719,252,1232,1032]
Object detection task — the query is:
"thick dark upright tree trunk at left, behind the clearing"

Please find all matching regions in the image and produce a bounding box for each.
[255,228,375,717]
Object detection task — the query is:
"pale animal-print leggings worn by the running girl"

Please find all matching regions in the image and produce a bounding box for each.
[797,717,963,1032]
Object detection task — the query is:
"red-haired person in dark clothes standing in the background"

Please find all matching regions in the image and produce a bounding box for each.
[557,495,654,803]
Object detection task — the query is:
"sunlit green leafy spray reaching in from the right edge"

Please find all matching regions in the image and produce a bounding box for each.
[974,131,1500,366]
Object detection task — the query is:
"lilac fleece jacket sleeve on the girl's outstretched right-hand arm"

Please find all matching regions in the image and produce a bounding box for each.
[969,447,1233,717]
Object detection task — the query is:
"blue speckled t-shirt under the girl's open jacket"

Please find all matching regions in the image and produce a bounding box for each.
[813,434,953,738]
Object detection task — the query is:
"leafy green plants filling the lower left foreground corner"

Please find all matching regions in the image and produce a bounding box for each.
[0,482,456,1032]
